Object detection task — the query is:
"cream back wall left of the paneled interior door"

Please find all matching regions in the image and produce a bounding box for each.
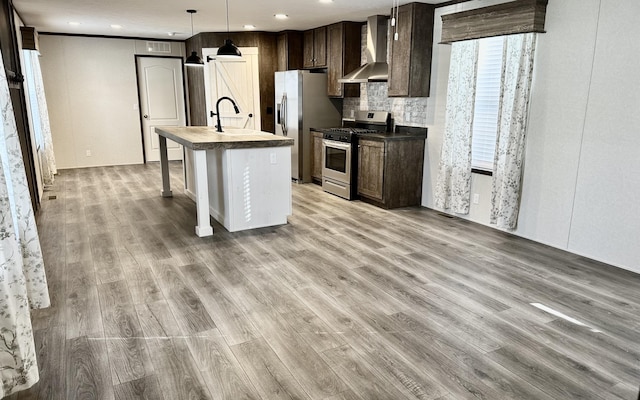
[40,35,184,169]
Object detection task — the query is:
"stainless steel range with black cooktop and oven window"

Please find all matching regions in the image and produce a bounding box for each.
[322,111,391,200]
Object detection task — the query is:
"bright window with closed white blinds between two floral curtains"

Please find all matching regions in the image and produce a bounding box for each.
[471,36,504,171]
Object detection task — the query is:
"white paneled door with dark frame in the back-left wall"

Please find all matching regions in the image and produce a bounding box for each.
[136,57,186,161]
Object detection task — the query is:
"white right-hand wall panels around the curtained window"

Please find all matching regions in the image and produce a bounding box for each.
[423,0,640,273]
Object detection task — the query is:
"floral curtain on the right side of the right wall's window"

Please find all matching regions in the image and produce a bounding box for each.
[490,33,536,230]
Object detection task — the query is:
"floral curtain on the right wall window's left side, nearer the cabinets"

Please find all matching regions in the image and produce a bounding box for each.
[435,40,478,214]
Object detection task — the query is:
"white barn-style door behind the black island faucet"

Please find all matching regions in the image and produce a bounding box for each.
[202,47,261,130]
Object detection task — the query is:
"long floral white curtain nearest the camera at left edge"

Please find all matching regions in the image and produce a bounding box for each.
[0,49,49,397]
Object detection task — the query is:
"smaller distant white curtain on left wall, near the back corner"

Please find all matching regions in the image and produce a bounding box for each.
[24,50,58,185]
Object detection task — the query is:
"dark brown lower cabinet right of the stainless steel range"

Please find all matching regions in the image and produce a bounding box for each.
[358,137,424,208]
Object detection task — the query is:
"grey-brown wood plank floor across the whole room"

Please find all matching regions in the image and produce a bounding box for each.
[12,163,640,400]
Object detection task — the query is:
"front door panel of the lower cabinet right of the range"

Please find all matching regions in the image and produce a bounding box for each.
[358,140,385,201]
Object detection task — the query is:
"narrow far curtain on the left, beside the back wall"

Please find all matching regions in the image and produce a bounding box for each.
[25,50,58,185]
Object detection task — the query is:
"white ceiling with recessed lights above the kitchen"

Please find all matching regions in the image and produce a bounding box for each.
[13,0,446,40]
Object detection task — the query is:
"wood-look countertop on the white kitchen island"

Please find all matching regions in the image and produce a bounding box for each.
[156,126,294,150]
